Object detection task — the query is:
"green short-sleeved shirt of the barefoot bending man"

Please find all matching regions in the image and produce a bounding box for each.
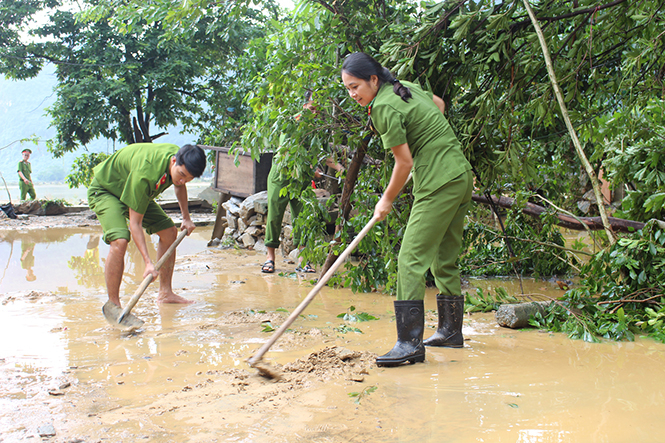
[94,143,180,214]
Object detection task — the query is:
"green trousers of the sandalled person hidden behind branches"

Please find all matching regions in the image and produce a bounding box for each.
[264,166,308,248]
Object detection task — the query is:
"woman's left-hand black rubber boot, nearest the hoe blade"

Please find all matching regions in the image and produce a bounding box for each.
[376,300,425,366]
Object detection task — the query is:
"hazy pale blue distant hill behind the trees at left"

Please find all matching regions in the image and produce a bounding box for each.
[0,65,196,184]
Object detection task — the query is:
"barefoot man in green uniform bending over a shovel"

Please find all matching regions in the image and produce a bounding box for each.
[88,143,206,306]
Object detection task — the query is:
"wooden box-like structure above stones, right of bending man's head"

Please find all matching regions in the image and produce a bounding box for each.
[198,145,273,198]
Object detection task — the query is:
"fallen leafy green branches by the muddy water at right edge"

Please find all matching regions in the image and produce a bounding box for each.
[533,221,665,342]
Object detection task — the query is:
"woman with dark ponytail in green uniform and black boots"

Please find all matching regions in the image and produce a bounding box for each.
[342,53,473,366]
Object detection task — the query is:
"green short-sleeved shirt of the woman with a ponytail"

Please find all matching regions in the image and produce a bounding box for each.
[370,81,471,196]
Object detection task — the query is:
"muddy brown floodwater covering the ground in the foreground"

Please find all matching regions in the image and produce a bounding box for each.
[0,228,665,443]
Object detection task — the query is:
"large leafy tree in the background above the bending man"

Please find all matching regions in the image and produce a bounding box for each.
[0,1,274,157]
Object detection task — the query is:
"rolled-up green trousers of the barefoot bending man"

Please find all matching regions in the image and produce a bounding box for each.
[88,179,175,244]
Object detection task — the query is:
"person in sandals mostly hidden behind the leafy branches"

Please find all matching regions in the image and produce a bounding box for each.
[261,91,344,274]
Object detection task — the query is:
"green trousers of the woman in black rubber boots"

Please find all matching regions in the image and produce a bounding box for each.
[397,171,473,300]
